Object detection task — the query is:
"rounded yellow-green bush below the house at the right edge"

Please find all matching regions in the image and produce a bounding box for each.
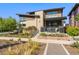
[66,26,79,36]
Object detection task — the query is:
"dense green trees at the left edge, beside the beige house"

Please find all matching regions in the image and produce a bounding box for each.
[0,17,17,32]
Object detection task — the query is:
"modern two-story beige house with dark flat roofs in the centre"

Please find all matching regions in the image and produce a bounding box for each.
[17,8,66,32]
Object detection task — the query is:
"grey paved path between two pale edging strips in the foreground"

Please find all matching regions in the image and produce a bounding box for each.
[47,43,67,55]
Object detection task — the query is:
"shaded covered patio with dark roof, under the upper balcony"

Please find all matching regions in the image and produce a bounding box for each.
[41,17,66,32]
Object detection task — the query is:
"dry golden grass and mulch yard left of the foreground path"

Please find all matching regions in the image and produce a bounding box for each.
[0,39,45,55]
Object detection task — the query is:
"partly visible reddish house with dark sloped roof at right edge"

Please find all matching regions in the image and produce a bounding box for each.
[68,4,79,27]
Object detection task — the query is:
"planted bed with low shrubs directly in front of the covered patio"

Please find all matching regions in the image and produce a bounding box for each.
[38,32,70,40]
